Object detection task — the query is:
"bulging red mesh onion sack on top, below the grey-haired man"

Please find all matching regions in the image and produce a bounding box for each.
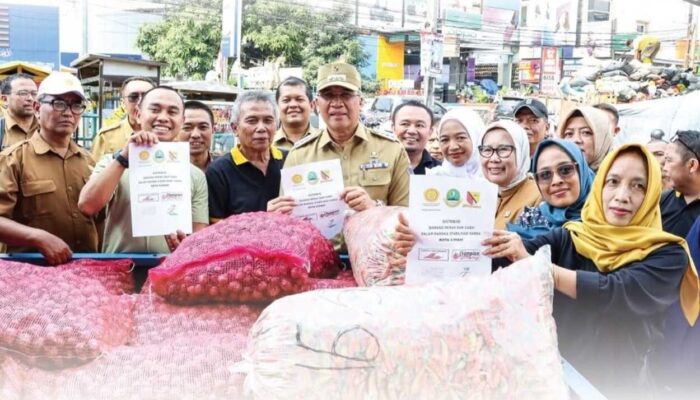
[148,212,340,304]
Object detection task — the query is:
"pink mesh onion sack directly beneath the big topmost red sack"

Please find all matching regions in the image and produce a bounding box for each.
[129,293,262,345]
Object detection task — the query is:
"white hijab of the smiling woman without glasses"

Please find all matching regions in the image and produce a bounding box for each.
[425,107,486,178]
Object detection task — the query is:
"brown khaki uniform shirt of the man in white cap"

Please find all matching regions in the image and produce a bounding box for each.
[0,135,98,253]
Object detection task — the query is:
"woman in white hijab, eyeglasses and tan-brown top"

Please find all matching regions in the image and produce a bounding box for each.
[479,121,541,229]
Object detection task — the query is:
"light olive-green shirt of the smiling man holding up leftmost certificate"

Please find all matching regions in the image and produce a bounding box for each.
[93,154,209,253]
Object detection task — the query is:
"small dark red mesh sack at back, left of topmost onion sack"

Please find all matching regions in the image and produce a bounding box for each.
[56,259,136,294]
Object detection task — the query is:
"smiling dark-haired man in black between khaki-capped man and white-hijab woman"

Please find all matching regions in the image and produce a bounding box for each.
[391,100,441,175]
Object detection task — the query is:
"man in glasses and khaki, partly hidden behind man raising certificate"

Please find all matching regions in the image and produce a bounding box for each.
[92,76,155,161]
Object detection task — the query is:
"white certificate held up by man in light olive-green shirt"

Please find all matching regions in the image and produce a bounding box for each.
[129,142,192,237]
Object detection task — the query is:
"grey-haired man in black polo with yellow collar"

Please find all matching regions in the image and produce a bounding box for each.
[206,91,286,224]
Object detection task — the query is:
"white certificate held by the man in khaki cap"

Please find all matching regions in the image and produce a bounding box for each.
[282,160,346,239]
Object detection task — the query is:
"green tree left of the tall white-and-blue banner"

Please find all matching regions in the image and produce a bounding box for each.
[136,0,222,79]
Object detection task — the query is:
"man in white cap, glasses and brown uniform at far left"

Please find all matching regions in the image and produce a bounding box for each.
[0,72,98,264]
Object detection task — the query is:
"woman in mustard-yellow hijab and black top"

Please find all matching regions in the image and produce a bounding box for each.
[482,144,700,398]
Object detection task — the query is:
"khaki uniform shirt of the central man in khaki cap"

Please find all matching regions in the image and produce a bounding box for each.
[284,124,410,206]
